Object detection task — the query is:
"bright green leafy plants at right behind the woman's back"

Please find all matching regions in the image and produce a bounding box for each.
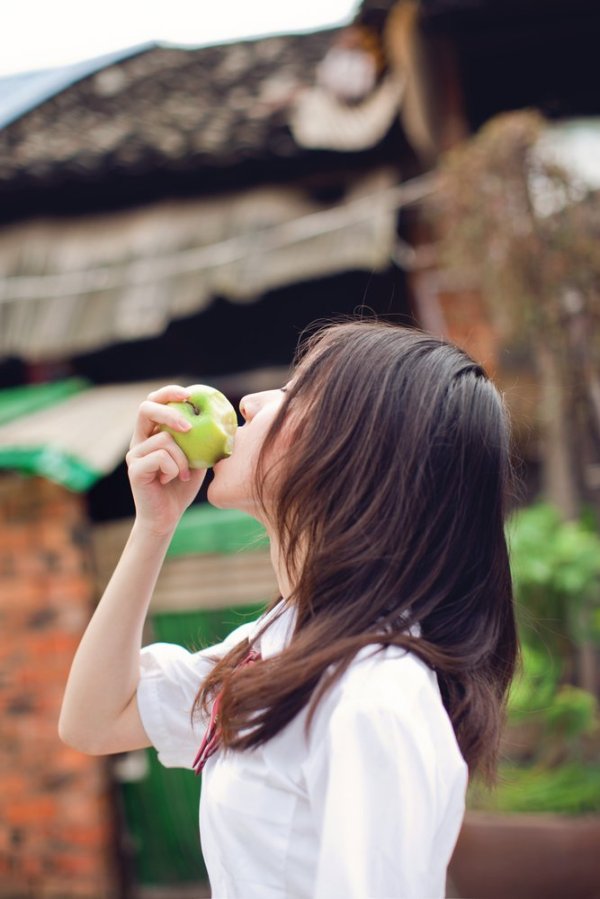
[468,503,600,814]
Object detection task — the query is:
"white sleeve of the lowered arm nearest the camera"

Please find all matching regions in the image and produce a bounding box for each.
[305,700,462,899]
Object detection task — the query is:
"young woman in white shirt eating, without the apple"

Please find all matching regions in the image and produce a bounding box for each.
[60,322,517,899]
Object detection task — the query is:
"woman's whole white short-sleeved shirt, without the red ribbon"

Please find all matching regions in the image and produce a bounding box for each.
[137,610,467,899]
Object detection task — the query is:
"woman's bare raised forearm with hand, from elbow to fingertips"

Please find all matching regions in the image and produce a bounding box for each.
[59,386,206,755]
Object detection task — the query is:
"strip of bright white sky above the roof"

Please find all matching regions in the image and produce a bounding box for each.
[0,0,359,75]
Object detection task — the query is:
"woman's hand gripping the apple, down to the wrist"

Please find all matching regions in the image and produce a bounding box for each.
[125,384,206,535]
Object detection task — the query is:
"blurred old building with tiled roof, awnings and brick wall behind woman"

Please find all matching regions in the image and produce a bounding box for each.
[0,0,600,897]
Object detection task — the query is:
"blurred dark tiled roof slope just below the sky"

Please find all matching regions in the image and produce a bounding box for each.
[0,29,356,190]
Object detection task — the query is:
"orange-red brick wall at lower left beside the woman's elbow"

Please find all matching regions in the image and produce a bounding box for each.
[0,473,119,899]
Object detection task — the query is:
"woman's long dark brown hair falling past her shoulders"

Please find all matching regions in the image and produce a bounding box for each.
[194,321,518,781]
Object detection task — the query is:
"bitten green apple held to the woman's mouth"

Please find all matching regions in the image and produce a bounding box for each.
[160,384,237,468]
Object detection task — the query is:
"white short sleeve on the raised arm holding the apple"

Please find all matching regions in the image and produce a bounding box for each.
[137,622,257,768]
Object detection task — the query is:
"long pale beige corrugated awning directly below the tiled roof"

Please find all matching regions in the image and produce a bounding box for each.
[0,169,431,360]
